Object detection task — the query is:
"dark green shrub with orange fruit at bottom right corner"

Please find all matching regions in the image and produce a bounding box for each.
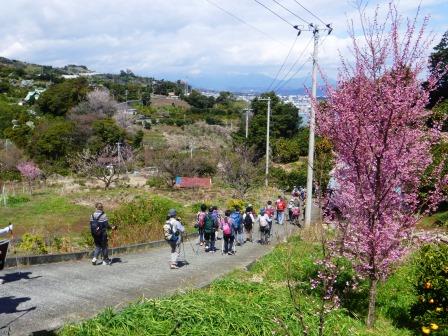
[411,243,448,335]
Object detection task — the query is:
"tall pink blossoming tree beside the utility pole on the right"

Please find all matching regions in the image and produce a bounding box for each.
[315,6,442,327]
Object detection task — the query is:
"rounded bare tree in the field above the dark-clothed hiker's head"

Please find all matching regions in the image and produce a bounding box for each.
[72,145,134,189]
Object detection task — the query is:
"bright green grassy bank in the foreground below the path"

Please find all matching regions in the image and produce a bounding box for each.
[60,239,412,336]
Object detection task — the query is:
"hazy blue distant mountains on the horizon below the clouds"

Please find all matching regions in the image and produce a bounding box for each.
[189,73,330,95]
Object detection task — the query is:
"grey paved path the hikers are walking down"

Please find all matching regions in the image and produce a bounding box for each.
[0,224,300,335]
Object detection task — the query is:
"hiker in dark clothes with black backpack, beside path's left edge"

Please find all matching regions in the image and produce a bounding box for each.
[90,202,117,266]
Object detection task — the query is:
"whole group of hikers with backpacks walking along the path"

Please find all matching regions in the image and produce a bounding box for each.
[0,187,306,269]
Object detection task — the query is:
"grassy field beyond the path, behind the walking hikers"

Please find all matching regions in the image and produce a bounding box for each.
[0,184,277,250]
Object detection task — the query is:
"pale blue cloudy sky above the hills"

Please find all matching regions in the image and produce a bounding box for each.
[0,0,448,89]
